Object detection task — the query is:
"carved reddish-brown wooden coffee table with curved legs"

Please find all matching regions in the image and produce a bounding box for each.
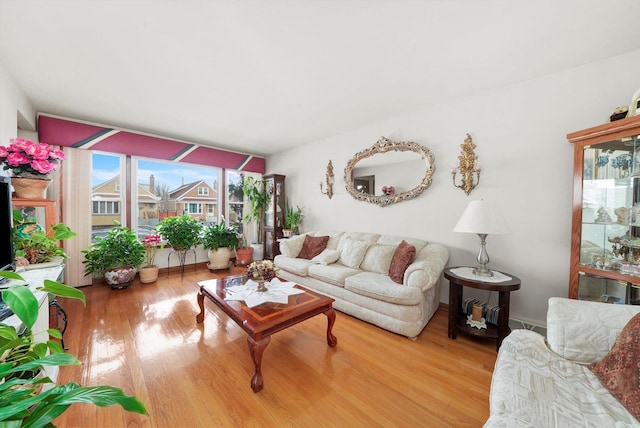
[196,275,338,392]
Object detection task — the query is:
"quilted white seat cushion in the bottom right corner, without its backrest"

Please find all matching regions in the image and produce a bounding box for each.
[485,330,640,428]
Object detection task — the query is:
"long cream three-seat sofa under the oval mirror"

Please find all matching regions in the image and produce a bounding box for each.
[274,231,449,338]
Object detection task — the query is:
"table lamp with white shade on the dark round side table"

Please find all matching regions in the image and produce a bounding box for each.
[453,200,511,276]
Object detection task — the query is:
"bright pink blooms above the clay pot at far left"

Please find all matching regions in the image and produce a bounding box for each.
[0,138,64,178]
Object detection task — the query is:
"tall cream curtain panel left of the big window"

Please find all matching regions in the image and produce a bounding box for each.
[61,147,91,287]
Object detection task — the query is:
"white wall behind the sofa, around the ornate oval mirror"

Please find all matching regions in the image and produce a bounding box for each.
[267,51,640,324]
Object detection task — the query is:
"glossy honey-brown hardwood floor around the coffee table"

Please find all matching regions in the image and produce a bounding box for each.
[54,266,496,427]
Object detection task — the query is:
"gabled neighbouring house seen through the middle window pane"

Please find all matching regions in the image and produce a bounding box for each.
[166,180,218,222]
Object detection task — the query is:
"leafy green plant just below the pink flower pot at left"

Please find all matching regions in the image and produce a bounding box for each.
[13,210,76,265]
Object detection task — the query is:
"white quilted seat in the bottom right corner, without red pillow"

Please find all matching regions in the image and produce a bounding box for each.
[485,297,640,428]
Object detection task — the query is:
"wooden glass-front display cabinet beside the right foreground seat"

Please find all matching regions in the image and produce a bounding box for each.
[567,116,640,304]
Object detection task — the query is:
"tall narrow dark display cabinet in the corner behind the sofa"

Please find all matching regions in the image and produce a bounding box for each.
[262,174,286,260]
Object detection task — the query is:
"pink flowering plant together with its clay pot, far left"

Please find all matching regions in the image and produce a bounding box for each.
[0,138,65,199]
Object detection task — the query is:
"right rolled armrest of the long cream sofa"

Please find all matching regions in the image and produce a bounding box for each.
[403,244,449,293]
